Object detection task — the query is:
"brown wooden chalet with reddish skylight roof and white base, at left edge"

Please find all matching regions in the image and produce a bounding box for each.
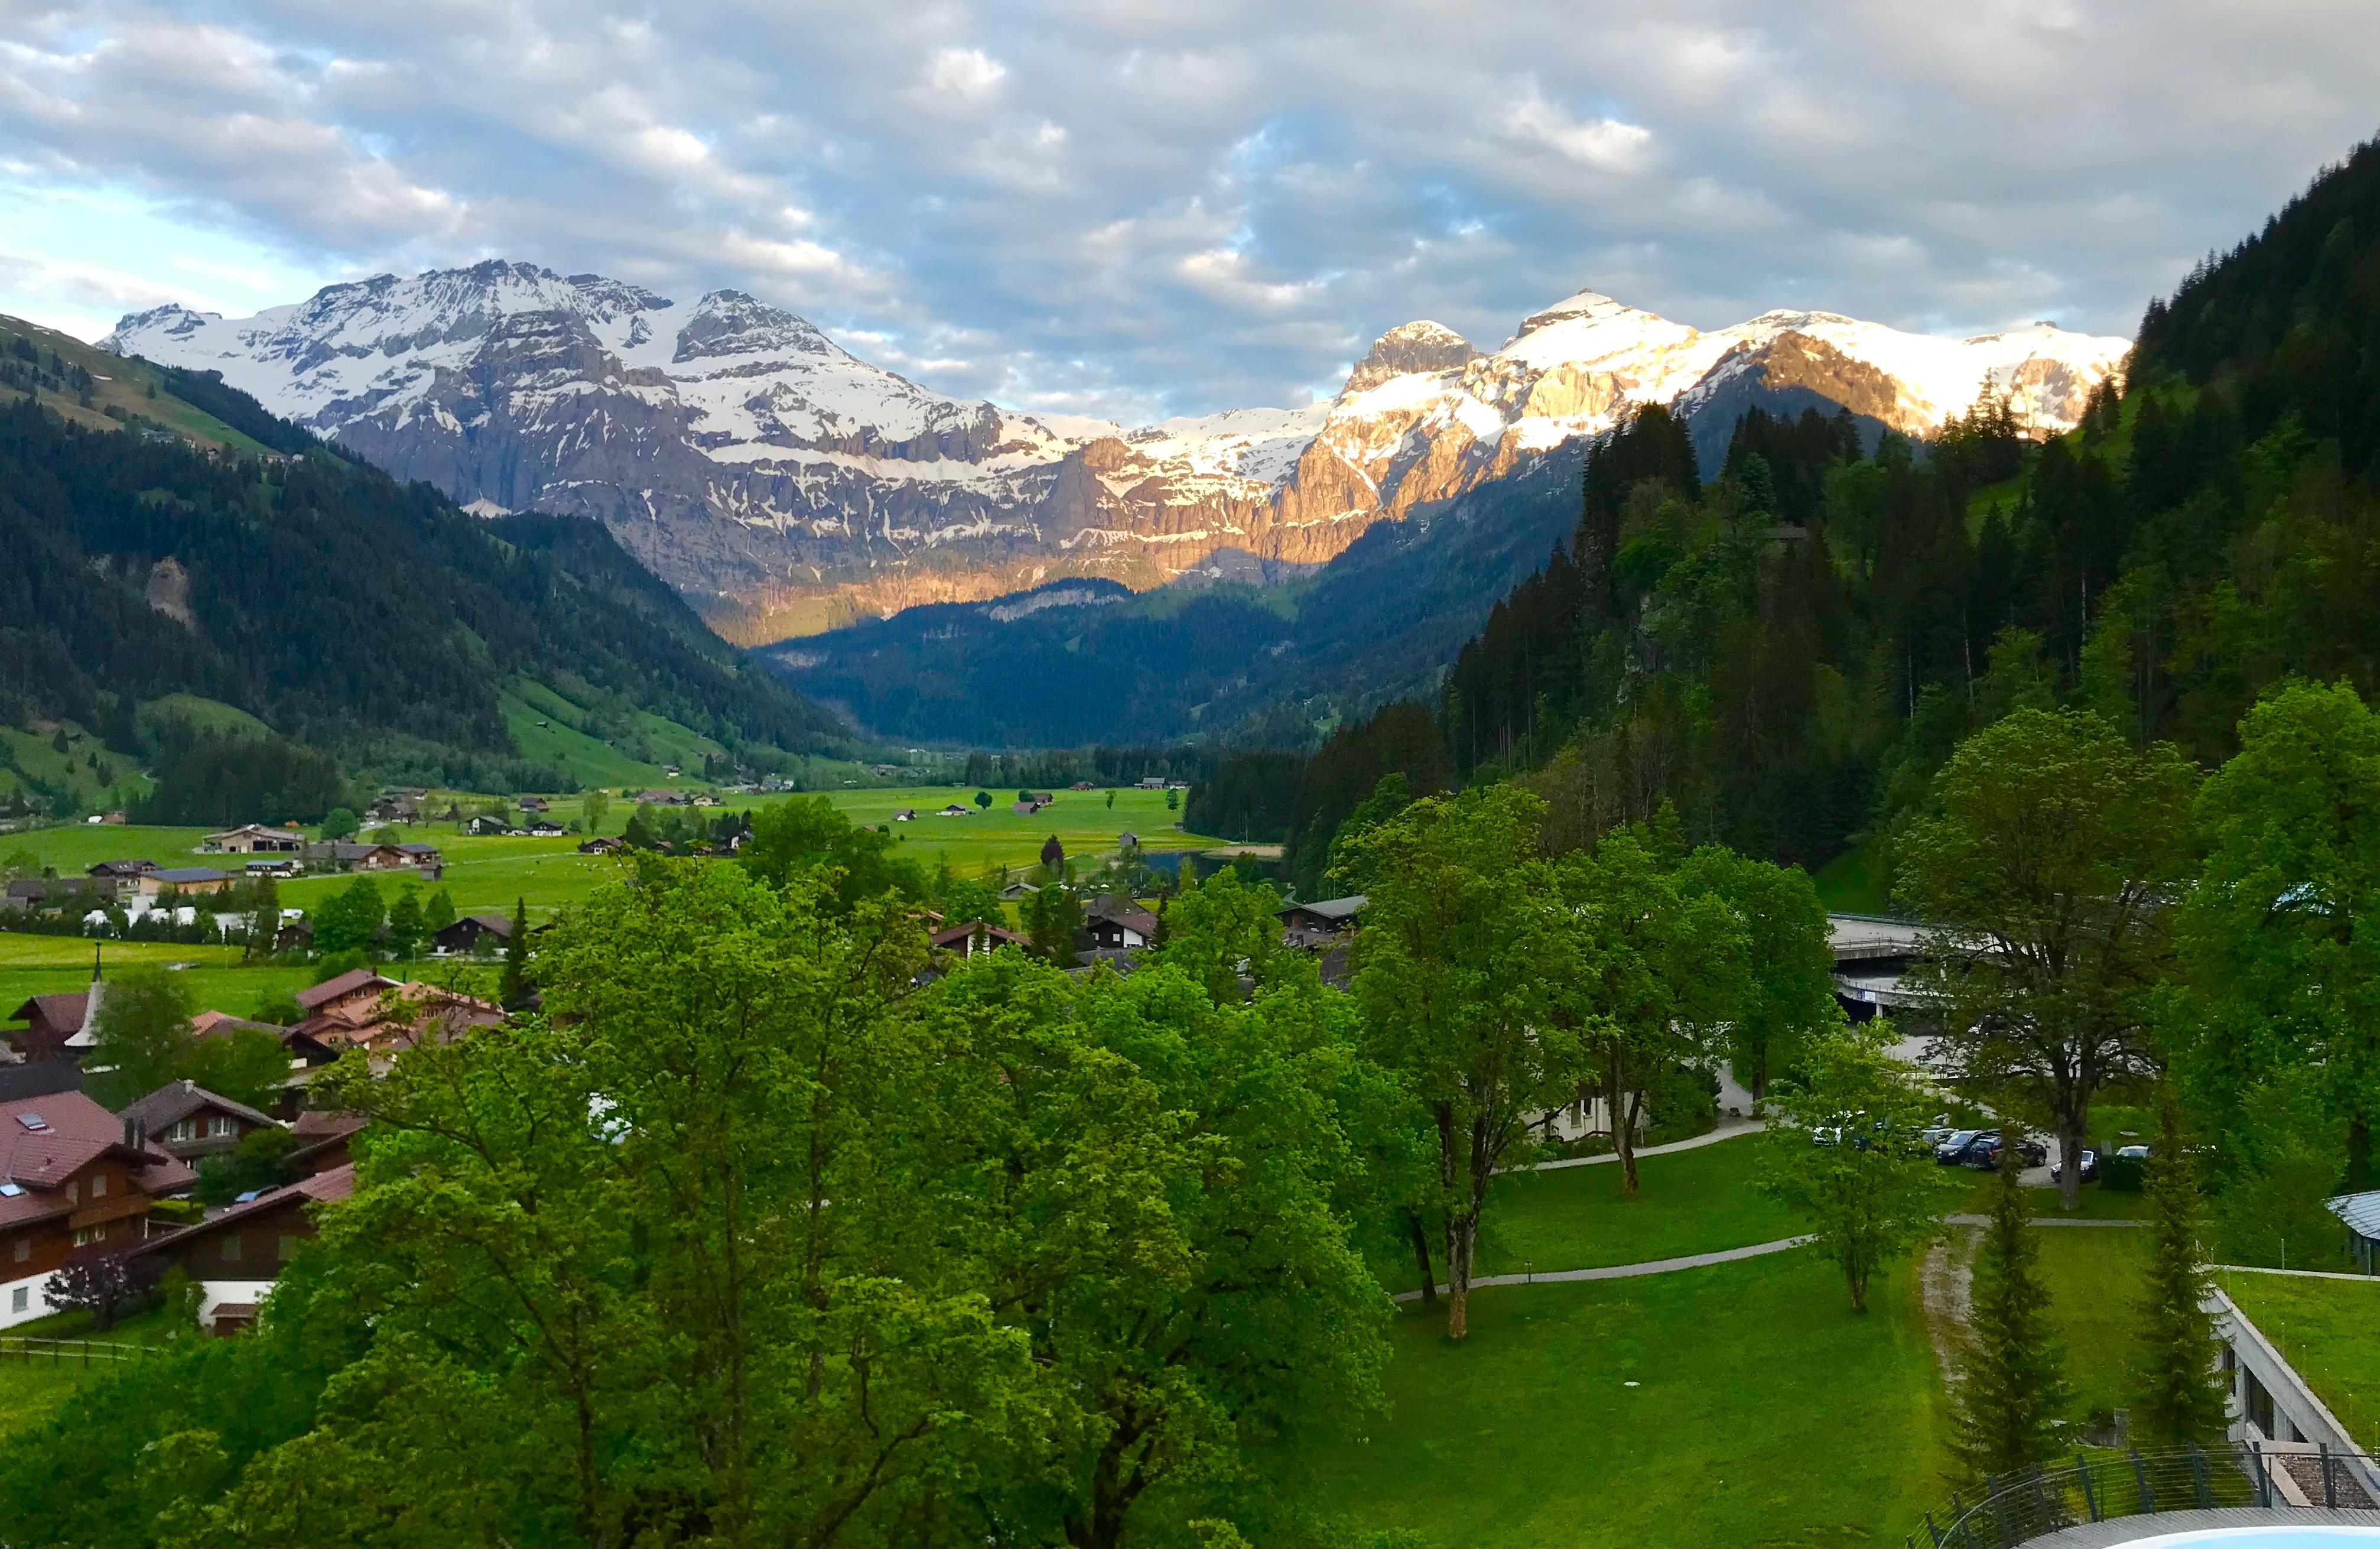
[0,1092,197,1328]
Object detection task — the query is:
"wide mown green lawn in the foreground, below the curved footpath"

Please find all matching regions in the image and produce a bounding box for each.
[1297,1252,1947,1544]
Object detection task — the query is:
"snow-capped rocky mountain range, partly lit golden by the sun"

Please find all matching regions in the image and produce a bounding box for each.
[102,262,2128,642]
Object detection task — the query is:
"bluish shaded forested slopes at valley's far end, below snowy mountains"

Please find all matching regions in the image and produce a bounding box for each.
[759,447,1581,749]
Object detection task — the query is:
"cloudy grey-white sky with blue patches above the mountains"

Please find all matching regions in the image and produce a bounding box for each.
[0,0,2380,419]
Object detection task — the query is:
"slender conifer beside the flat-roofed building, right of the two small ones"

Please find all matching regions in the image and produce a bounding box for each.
[2132,1087,2228,1444]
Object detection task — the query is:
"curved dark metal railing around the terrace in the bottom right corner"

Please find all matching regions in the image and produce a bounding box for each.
[1906,1442,2380,1549]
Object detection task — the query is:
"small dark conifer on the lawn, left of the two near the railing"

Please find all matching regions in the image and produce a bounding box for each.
[1959,1125,2073,1477]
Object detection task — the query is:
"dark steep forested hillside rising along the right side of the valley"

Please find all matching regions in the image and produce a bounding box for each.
[1192,145,2380,904]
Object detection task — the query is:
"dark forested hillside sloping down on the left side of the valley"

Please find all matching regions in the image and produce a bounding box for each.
[0,345,840,804]
